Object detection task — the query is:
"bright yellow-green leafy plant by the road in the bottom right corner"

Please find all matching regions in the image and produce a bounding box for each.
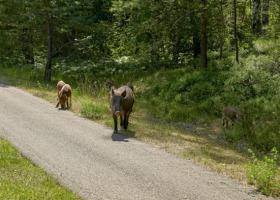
[245,148,280,195]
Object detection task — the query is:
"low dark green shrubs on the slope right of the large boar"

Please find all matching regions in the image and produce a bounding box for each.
[137,64,230,122]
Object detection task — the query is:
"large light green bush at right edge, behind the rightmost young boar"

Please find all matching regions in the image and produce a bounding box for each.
[224,39,280,151]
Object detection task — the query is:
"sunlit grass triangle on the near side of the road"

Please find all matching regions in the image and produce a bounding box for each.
[0,138,81,200]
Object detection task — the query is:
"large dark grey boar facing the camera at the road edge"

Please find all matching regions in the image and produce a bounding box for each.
[110,86,134,133]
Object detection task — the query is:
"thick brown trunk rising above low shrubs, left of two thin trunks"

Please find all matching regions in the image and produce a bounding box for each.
[200,0,208,68]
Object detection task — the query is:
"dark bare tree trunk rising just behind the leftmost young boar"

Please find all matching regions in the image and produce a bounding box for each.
[43,0,53,82]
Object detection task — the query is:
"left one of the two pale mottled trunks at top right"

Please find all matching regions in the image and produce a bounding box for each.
[252,0,261,34]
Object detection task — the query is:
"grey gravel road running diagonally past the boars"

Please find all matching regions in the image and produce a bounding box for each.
[0,82,273,200]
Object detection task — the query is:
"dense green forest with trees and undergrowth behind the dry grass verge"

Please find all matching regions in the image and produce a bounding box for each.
[0,0,280,152]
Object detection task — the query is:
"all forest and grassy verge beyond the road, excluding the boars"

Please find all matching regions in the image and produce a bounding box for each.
[0,0,280,196]
